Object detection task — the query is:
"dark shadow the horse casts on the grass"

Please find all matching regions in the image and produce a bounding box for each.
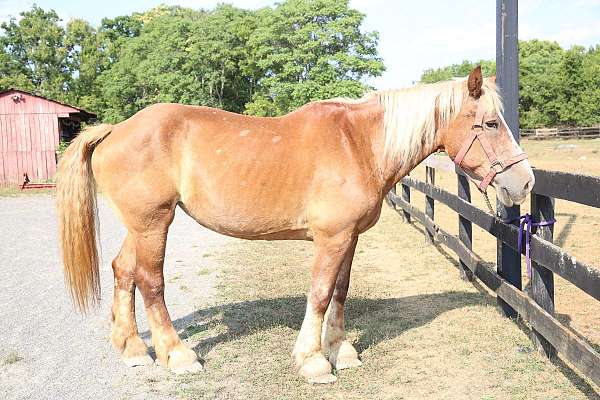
[158,291,482,355]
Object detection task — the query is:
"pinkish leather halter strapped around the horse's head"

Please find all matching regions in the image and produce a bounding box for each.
[454,103,527,193]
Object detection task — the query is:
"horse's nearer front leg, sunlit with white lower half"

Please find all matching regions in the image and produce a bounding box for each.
[293,231,355,383]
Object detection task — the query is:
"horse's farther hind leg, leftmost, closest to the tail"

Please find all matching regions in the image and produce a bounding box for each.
[110,234,153,367]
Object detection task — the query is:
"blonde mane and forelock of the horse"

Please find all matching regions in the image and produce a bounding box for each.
[326,79,502,165]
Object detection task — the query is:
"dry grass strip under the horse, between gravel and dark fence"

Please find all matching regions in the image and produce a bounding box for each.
[171,208,599,400]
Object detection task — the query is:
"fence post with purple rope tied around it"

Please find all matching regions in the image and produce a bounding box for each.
[531,193,556,357]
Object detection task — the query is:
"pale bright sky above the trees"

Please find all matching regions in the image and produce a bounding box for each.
[0,0,600,89]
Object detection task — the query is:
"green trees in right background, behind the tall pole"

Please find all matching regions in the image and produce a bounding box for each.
[421,40,600,128]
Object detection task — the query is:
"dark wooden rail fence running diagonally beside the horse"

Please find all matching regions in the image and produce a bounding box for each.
[387,156,600,385]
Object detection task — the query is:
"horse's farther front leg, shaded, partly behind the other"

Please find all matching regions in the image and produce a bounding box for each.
[321,237,362,370]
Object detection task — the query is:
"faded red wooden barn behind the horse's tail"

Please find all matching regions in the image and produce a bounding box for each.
[0,89,96,184]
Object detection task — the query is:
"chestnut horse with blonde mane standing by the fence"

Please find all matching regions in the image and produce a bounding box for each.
[58,68,534,382]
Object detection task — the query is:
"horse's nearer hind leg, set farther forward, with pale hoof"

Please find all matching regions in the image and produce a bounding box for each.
[134,227,202,373]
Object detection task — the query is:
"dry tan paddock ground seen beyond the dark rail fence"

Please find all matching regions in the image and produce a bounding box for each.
[411,139,600,350]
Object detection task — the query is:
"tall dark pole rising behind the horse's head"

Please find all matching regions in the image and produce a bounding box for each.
[496,0,522,317]
